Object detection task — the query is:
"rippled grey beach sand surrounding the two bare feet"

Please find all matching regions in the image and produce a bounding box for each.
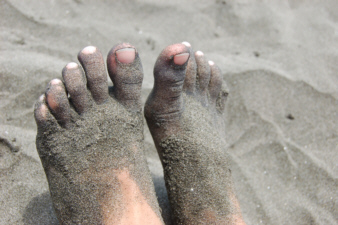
[0,0,338,225]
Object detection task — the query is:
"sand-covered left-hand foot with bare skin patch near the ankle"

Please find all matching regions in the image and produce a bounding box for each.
[35,44,162,225]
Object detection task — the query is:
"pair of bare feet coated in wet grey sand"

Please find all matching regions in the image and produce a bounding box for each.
[35,42,244,225]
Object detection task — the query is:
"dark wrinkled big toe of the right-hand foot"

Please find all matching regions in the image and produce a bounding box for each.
[147,44,190,118]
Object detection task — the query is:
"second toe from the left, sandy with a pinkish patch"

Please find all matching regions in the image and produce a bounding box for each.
[45,79,70,127]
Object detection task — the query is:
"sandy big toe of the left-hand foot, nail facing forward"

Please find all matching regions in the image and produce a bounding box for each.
[107,43,143,111]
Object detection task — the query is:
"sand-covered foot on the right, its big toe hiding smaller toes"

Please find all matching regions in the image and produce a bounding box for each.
[145,43,244,225]
